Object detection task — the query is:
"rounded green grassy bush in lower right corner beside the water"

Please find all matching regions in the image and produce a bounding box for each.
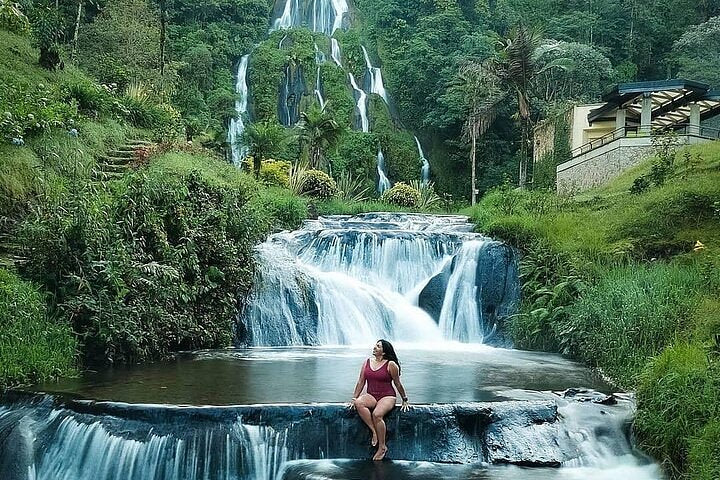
[635,343,720,479]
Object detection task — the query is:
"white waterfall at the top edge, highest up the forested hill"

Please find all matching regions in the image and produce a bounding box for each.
[272,0,349,36]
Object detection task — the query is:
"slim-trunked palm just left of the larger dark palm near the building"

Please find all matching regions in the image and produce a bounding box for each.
[450,62,505,205]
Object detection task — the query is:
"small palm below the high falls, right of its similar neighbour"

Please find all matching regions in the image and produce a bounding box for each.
[298,104,343,170]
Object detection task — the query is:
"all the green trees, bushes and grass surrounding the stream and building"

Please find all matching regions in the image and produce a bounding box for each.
[0,0,720,480]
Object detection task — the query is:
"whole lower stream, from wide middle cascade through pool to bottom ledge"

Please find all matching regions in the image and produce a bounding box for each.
[0,213,663,480]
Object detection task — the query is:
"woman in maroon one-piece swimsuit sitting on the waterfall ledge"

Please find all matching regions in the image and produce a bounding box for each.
[350,340,410,460]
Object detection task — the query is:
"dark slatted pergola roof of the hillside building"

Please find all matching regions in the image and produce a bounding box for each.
[588,79,720,127]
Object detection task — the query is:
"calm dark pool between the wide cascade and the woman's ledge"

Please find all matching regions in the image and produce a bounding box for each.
[32,342,612,405]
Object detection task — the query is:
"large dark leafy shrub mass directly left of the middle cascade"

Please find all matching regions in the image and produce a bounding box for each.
[22,153,292,362]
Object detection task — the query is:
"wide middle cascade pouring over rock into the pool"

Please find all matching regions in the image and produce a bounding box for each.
[239,216,518,345]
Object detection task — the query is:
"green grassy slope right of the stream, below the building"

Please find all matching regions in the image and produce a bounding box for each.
[466,142,720,480]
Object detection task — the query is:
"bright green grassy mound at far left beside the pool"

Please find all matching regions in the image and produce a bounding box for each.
[0,269,77,386]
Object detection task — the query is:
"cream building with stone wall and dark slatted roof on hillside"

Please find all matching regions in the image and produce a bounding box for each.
[534,79,720,193]
